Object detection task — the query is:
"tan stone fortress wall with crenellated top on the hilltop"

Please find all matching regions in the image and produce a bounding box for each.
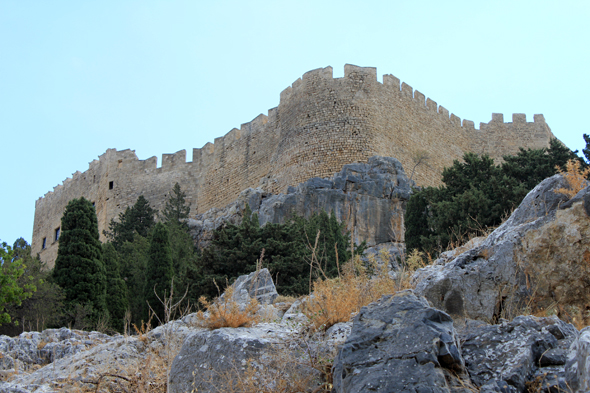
[32,64,553,267]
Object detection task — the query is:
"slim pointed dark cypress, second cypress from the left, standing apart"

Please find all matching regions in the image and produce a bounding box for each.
[145,222,173,325]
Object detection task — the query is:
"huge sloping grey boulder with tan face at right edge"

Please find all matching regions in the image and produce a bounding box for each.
[414,175,590,322]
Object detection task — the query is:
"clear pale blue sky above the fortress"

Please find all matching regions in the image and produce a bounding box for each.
[0,0,590,244]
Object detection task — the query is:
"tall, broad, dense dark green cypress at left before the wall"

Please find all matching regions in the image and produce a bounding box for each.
[53,197,106,323]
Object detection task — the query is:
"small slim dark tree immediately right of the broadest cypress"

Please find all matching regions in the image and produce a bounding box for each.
[102,243,129,332]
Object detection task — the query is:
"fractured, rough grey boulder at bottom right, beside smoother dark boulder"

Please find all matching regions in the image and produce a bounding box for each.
[459,316,577,392]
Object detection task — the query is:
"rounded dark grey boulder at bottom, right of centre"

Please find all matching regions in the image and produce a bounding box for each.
[333,291,468,393]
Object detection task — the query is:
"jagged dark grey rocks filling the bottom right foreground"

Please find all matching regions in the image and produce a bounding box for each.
[333,291,588,393]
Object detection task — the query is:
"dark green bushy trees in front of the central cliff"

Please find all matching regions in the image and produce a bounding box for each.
[199,206,364,297]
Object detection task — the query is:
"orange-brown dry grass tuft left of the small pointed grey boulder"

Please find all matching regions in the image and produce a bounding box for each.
[197,286,259,329]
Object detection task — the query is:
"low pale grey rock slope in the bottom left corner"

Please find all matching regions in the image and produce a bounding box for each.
[0,318,195,393]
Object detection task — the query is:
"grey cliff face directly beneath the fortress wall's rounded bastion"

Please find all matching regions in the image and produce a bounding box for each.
[188,156,412,248]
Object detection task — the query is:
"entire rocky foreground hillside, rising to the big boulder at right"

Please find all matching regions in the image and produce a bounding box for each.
[0,175,590,393]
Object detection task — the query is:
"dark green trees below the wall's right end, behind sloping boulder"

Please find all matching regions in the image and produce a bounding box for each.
[405,139,579,253]
